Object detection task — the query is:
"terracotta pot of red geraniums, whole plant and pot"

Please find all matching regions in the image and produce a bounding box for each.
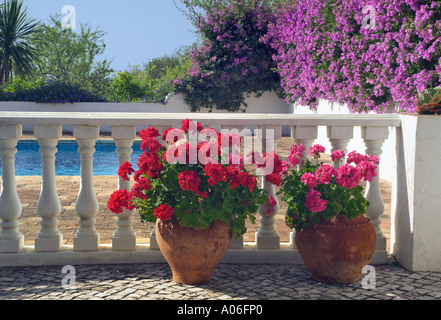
[108,119,273,284]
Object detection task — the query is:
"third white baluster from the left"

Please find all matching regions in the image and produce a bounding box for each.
[74,125,100,251]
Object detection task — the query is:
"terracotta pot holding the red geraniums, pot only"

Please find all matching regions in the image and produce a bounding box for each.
[155,219,232,285]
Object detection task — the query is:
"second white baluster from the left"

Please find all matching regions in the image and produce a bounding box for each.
[34,125,63,252]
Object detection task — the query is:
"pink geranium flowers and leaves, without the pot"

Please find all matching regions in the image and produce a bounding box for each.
[279,144,379,231]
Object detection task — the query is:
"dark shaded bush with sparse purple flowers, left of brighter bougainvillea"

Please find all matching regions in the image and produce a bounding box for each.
[175,0,283,111]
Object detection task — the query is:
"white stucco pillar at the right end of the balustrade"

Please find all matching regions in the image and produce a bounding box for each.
[391,115,441,272]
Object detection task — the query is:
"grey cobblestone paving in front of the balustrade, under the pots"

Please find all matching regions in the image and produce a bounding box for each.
[0,263,441,301]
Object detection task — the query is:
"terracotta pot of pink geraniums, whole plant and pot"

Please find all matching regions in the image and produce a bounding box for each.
[279,145,379,283]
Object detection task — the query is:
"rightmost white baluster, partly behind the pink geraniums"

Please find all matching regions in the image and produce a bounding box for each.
[361,127,389,262]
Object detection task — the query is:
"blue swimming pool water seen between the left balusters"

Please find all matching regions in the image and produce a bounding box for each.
[0,140,143,176]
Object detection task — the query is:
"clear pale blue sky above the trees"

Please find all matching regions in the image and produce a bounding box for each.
[23,0,197,71]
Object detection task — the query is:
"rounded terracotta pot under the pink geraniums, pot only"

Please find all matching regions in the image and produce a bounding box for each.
[295,215,377,283]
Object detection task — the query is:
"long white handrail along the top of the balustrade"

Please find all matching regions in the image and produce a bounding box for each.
[0,111,401,127]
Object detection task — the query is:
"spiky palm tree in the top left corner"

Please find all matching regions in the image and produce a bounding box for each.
[0,0,40,85]
